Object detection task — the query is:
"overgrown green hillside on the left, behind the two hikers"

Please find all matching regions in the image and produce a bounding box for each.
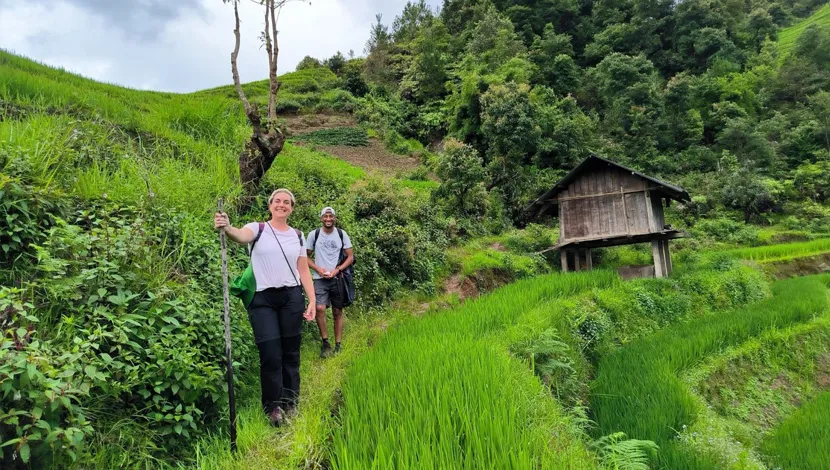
[0,51,448,468]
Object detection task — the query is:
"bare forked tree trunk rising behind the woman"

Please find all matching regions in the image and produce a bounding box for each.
[231,0,285,210]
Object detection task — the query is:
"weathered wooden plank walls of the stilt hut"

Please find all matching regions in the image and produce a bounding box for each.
[558,166,665,241]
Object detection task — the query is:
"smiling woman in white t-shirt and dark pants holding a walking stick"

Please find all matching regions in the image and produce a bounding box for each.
[214,189,316,426]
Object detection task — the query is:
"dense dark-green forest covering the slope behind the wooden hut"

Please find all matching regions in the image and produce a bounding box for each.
[298,0,830,230]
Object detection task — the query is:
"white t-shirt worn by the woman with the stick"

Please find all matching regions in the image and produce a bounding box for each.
[244,222,307,292]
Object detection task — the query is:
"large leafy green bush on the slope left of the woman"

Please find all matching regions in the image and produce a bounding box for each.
[0,201,252,464]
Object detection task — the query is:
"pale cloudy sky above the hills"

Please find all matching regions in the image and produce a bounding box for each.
[0,0,442,92]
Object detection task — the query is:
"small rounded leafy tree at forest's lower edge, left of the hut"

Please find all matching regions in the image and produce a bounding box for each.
[433,138,487,218]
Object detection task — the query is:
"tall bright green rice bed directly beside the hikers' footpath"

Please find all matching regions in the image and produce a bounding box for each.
[331,271,619,469]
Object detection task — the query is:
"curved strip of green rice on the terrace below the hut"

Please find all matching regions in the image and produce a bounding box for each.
[591,275,828,469]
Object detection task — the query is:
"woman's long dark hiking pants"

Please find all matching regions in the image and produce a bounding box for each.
[248,286,305,413]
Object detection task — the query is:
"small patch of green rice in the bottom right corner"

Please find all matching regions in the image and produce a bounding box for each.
[763,392,830,470]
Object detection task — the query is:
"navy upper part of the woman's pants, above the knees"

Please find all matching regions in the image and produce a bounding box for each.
[248,286,305,343]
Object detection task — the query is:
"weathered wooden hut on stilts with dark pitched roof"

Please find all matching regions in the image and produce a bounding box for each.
[527,154,690,277]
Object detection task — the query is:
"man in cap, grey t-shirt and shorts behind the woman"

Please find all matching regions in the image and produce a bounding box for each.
[306,207,354,358]
